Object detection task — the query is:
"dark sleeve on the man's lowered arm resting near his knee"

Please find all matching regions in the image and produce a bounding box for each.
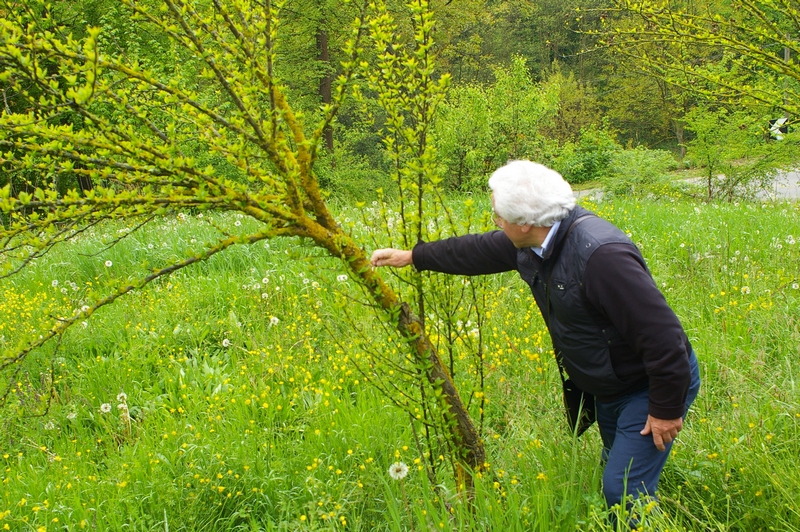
[584,244,691,419]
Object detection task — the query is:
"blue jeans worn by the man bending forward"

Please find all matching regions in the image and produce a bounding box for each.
[596,351,700,507]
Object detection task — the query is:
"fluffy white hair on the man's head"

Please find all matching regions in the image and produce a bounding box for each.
[489,161,575,227]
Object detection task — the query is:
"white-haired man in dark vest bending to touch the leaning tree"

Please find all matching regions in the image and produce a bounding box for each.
[372,161,700,506]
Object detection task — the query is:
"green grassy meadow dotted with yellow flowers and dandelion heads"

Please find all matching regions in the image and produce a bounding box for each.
[0,194,800,532]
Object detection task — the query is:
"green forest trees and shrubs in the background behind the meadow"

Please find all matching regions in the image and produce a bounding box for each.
[0,0,800,199]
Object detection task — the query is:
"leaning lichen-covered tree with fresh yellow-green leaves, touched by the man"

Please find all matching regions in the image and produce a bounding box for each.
[0,0,485,486]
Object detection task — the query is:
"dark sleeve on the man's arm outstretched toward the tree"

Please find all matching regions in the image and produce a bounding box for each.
[412,231,517,275]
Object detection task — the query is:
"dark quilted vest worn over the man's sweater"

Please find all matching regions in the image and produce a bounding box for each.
[517,207,647,397]
